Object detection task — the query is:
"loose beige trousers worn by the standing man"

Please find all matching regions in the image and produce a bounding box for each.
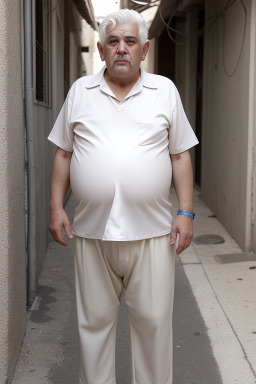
[74,235,175,384]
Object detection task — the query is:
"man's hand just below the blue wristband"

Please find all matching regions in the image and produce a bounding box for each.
[170,215,193,255]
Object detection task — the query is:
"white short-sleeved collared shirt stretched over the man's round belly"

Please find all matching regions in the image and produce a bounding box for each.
[49,67,198,241]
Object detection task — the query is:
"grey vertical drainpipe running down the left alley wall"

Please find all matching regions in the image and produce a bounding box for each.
[23,0,36,303]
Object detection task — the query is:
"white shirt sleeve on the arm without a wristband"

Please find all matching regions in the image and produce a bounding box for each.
[48,88,74,152]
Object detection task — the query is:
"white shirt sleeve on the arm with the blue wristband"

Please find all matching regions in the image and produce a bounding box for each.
[169,85,198,154]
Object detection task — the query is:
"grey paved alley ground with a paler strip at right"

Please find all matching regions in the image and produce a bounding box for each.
[12,193,256,384]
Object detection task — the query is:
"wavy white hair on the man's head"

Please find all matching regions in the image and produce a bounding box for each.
[99,9,148,46]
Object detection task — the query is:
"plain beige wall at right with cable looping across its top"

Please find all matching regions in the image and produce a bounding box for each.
[202,0,252,249]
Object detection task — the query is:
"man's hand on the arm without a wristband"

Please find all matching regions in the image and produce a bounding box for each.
[49,208,73,245]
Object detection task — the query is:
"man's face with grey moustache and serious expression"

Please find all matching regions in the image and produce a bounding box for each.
[98,23,149,78]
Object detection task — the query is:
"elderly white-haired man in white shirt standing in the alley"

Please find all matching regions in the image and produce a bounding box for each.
[49,10,198,384]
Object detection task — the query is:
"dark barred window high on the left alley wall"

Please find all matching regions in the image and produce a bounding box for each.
[34,0,50,105]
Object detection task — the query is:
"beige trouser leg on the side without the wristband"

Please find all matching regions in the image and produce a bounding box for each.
[74,236,122,384]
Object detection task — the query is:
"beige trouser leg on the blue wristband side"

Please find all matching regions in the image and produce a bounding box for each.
[124,236,175,384]
